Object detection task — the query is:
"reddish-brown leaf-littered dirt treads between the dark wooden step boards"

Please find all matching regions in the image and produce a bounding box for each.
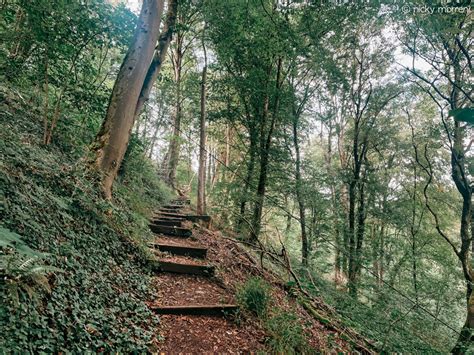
[146,201,265,354]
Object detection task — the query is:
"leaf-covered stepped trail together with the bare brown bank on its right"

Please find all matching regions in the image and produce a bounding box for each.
[143,199,365,353]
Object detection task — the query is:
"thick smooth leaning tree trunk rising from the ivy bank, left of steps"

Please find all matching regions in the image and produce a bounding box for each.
[91,0,164,199]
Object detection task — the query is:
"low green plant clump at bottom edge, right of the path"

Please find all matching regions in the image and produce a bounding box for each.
[266,312,309,354]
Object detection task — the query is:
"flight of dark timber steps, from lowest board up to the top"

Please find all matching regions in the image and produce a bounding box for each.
[150,198,238,316]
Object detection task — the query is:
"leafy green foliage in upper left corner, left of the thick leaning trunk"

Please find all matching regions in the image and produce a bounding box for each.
[0,0,136,157]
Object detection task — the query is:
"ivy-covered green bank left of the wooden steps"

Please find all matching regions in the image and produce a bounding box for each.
[0,87,170,353]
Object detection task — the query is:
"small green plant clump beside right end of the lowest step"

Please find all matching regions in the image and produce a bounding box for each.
[237,277,270,318]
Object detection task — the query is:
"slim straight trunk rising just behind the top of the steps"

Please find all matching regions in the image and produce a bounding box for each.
[197,31,207,214]
